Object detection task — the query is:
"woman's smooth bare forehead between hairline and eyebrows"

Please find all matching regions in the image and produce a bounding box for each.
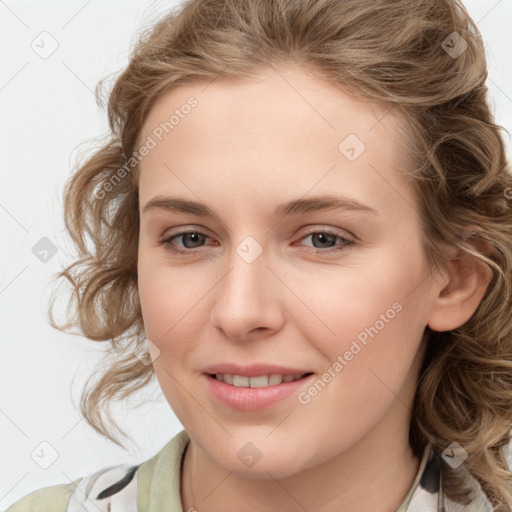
[139,63,412,217]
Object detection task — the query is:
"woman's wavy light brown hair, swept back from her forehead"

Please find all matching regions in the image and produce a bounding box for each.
[50,0,512,511]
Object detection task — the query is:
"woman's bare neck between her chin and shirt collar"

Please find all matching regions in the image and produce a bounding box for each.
[181,401,420,512]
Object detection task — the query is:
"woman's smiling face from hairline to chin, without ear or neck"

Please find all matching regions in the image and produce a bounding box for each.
[138,67,440,478]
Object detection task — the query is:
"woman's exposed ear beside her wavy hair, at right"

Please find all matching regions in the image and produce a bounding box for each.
[428,235,494,332]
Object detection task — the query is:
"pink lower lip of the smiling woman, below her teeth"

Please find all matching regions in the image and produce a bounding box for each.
[202,374,314,411]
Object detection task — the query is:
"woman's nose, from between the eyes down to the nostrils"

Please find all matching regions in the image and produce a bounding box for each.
[211,242,285,341]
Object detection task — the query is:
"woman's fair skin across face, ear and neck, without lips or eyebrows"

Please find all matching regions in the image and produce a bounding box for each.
[138,66,490,512]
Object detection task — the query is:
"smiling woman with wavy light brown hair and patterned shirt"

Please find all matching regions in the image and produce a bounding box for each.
[9,0,512,512]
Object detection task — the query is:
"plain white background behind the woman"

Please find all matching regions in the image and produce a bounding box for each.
[0,0,512,509]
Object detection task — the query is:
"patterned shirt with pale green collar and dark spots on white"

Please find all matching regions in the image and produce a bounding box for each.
[7,430,504,512]
